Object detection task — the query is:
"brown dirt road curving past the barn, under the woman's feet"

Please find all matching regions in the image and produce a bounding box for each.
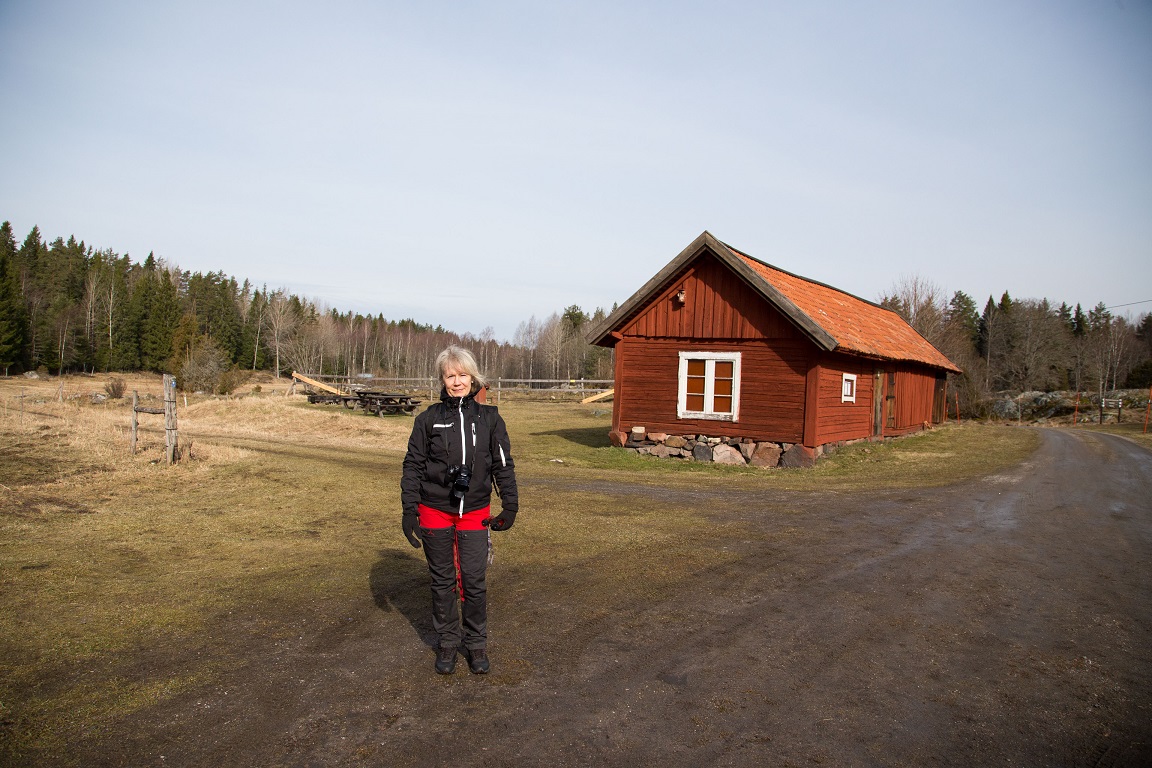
[68,431,1152,767]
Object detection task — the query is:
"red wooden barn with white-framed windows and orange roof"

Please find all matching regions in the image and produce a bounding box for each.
[588,231,960,465]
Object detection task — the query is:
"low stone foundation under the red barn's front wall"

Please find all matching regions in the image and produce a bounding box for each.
[609,427,825,469]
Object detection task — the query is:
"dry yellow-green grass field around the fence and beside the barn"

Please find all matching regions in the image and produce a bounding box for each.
[0,377,1037,765]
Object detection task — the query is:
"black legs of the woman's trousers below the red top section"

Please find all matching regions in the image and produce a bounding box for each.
[420,526,488,651]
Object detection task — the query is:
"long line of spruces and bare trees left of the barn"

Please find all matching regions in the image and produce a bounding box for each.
[0,221,613,393]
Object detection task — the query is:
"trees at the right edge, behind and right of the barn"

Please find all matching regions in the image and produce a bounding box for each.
[880,276,1152,410]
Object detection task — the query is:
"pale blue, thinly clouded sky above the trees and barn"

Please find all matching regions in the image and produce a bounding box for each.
[0,0,1152,339]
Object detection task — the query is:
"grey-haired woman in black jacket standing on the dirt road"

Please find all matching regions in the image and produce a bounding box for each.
[400,347,517,675]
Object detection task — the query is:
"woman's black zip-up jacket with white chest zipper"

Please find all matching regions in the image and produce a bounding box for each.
[400,389,518,515]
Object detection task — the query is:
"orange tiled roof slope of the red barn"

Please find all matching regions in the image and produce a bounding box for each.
[725,244,961,373]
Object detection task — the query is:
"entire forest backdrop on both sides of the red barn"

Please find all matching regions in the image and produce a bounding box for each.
[0,221,1152,413]
